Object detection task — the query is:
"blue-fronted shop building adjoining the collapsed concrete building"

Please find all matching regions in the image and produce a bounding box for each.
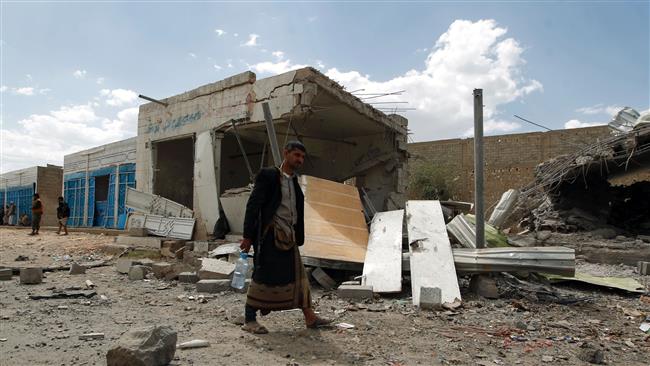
[59,137,136,229]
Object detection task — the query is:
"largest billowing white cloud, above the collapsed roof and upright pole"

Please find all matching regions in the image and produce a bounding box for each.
[251,19,543,141]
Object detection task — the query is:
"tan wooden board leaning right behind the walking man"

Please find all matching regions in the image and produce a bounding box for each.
[300,175,368,263]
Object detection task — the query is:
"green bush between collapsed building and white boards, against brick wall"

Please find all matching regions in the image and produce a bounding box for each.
[408,163,453,200]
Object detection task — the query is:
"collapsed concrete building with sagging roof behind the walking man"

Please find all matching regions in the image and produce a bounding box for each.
[136,68,407,238]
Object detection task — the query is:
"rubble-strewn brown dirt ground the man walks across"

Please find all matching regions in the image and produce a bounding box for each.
[0,228,650,366]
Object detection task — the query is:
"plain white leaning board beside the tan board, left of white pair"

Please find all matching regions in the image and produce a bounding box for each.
[362,210,404,293]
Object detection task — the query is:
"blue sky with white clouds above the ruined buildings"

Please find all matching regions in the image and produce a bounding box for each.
[0,0,650,172]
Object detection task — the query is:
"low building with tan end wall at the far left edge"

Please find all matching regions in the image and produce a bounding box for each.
[0,164,63,226]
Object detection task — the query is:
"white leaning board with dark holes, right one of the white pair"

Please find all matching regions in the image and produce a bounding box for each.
[406,201,461,306]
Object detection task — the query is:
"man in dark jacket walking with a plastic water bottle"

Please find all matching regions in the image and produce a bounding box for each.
[241,141,331,334]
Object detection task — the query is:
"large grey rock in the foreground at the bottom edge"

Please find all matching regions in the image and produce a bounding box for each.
[106,326,177,366]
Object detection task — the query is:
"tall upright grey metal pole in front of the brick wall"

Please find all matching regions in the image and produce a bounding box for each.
[474,89,485,248]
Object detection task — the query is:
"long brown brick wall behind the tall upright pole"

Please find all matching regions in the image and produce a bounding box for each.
[408,126,611,207]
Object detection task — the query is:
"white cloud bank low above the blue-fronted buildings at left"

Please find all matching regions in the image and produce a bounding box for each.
[0,104,138,171]
